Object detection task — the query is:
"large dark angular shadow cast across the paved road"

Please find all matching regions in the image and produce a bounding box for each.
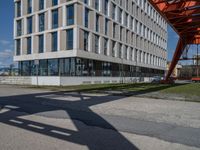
[0,92,138,150]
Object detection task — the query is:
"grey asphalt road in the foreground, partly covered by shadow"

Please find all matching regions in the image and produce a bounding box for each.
[0,85,200,150]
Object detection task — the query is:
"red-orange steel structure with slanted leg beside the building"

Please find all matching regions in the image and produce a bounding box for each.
[149,0,200,81]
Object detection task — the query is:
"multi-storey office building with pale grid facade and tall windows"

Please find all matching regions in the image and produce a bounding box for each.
[14,0,167,84]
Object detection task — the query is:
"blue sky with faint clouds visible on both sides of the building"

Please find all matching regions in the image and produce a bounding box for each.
[0,0,178,67]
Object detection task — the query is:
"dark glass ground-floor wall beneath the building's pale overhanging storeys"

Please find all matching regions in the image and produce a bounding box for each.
[19,58,165,77]
